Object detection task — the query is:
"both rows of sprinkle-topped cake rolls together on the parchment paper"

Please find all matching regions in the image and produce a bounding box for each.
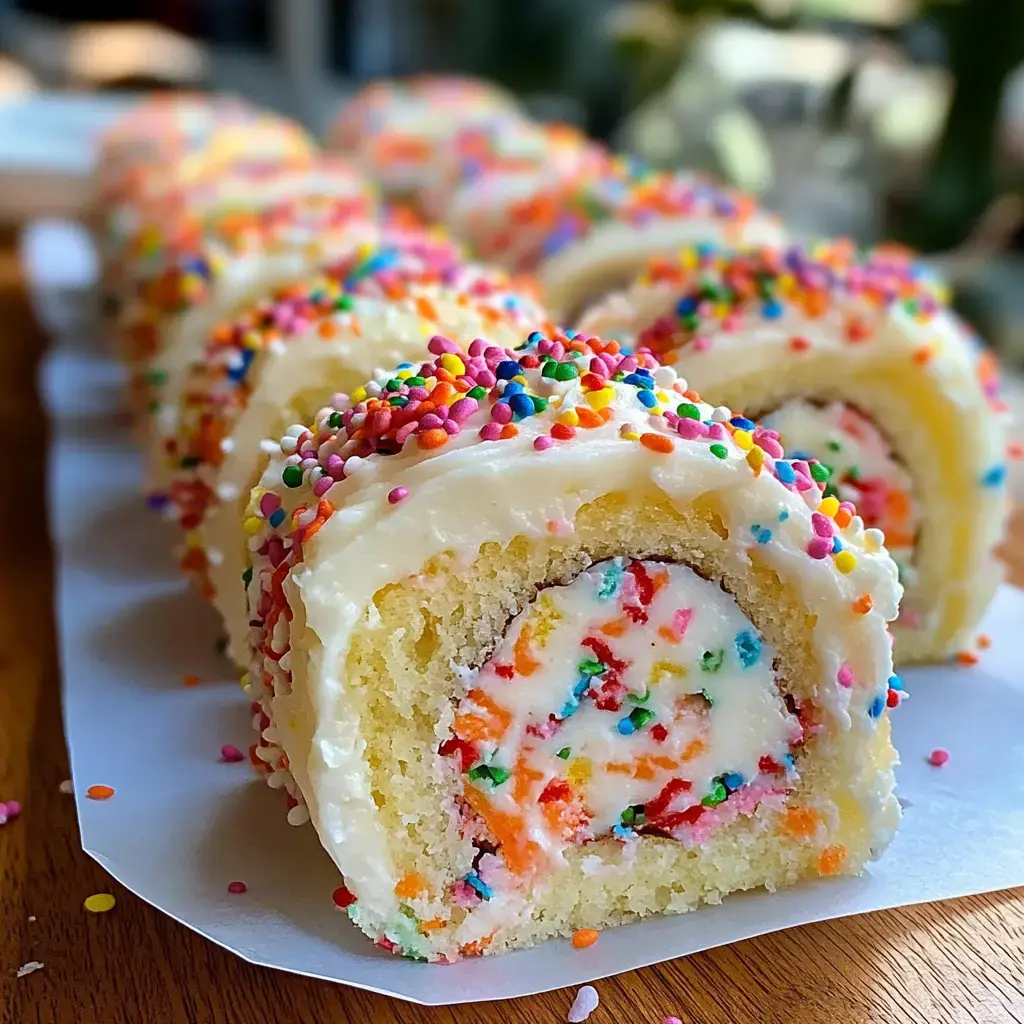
[94,80,1006,961]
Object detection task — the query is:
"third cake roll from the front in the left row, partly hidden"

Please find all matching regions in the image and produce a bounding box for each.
[122,190,382,454]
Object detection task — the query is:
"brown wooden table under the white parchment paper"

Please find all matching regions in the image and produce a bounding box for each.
[0,241,1024,1024]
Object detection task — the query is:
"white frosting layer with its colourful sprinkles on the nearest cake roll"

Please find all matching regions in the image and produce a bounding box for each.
[241,334,901,950]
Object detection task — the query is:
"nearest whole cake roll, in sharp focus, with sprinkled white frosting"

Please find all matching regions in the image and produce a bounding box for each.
[247,332,900,962]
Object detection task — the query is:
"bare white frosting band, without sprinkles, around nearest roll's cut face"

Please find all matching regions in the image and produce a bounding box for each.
[250,382,901,927]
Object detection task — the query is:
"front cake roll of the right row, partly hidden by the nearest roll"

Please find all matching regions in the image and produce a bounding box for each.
[583,243,1007,663]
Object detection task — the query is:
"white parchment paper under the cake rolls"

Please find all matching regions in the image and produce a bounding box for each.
[32,218,1024,1005]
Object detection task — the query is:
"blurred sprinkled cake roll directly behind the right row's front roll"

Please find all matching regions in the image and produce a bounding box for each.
[447,158,784,323]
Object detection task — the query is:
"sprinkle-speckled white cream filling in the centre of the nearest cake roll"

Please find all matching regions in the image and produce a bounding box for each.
[454,558,803,873]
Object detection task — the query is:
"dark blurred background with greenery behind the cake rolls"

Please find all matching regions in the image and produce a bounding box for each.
[0,0,1024,376]
